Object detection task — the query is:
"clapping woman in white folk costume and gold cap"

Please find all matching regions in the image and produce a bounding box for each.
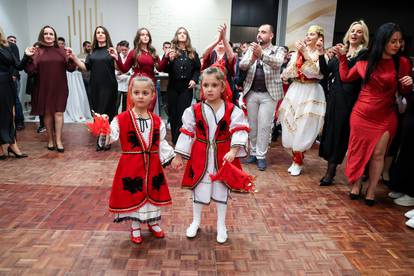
[278,25,326,176]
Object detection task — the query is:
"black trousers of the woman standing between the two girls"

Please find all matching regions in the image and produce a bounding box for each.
[167,88,193,145]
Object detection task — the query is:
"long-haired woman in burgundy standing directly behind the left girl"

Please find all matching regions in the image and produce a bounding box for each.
[111,28,168,112]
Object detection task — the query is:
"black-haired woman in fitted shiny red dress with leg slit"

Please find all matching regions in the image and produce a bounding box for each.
[337,23,413,206]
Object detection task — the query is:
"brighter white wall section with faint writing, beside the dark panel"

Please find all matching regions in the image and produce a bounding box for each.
[138,0,231,55]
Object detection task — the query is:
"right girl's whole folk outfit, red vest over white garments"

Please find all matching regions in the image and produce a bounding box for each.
[175,102,249,204]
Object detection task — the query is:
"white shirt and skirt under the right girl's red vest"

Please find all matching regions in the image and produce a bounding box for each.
[175,102,249,204]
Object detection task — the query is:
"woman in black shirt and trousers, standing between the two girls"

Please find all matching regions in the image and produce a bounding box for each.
[165,27,201,145]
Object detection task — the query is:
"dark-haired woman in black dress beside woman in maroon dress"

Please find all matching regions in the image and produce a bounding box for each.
[70,26,118,151]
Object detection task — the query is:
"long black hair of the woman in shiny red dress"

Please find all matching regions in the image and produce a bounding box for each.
[364,23,402,83]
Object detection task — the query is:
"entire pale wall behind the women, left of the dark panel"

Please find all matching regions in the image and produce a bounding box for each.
[0,0,231,54]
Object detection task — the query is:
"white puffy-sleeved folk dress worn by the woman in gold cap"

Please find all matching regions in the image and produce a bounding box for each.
[278,51,326,152]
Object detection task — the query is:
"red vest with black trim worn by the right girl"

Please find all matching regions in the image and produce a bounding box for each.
[182,102,241,189]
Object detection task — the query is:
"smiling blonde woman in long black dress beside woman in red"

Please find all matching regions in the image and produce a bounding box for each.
[319,20,369,186]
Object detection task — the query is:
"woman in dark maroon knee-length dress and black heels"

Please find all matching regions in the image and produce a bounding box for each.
[26,26,76,152]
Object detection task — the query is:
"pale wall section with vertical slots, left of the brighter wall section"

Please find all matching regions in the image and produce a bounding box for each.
[27,0,138,53]
